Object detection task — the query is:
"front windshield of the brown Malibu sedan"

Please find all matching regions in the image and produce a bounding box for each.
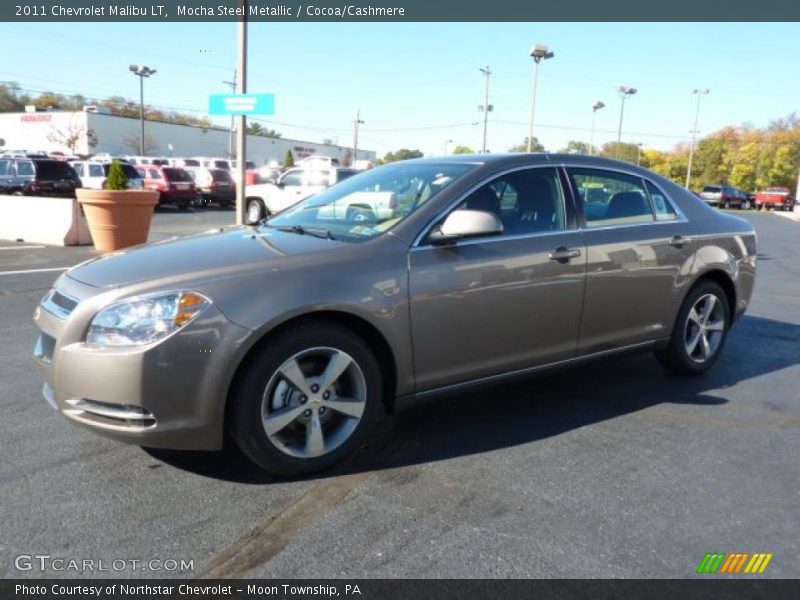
[267,163,474,242]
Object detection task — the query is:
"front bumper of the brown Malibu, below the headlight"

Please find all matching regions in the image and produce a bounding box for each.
[34,277,251,450]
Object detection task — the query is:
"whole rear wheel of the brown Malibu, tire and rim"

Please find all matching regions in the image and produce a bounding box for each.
[656,280,731,375]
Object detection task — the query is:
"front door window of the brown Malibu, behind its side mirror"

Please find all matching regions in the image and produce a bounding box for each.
[456,168,567,235]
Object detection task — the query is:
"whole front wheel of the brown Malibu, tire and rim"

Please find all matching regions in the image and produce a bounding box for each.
[228,321,383,476]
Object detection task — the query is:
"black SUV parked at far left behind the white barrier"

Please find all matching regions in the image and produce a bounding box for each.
[0,158,81,198]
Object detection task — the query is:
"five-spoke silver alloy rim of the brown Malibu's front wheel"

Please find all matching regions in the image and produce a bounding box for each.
[261,347,367,459]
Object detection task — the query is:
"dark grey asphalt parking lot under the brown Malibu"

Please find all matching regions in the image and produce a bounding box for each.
[0,210,800,578]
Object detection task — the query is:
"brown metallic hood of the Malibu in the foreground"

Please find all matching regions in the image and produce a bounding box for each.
[66,227,346,288]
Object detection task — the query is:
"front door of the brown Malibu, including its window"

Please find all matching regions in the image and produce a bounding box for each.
[409,168,586,391]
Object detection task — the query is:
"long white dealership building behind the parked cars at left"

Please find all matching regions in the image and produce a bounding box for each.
[0,110,376,166]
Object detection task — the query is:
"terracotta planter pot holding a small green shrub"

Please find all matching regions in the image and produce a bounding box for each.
[76,188,158,252]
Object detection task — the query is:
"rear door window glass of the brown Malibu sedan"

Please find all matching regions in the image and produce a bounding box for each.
[569,169,654,227]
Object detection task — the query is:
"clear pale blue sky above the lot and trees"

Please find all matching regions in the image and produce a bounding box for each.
[0,23,800,155]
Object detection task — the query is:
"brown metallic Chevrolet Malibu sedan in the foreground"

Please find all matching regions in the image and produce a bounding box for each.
[34,154,756,475]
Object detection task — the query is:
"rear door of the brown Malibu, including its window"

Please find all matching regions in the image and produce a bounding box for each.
[567,168,695,354]
